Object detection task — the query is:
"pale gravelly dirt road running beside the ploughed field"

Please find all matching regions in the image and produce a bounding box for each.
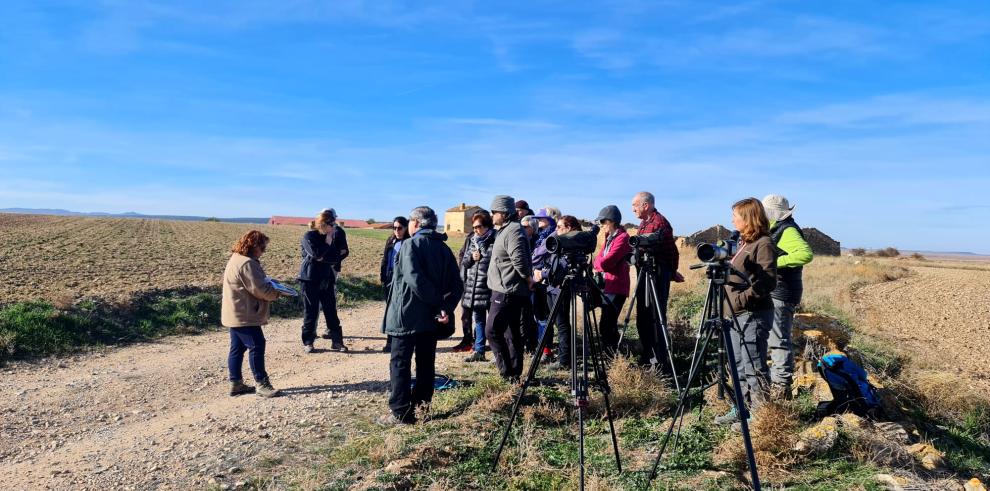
[0,303,460,490]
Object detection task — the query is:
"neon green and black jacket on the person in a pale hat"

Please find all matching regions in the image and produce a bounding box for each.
[770,217,814,305]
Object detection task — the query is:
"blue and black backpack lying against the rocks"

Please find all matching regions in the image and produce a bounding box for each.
[818,353,881,416]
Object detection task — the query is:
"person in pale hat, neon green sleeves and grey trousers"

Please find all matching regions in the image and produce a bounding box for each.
[763,194,814,400]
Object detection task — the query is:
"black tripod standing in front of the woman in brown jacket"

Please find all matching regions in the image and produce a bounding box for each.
[650,260,760,490]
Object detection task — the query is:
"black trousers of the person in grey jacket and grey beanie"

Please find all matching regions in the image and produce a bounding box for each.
[485,292,529,378]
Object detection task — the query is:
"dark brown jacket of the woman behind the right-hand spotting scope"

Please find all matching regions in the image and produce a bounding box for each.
[727,236,777,314]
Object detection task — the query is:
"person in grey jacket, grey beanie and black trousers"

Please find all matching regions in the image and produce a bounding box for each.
[485,195,533,383]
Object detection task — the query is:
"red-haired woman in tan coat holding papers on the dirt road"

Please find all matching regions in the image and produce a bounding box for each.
[220,230,279,397]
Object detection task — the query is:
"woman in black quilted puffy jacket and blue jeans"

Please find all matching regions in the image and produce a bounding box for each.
[461,211,495,362]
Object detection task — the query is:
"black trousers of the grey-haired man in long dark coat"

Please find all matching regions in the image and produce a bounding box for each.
[388,332,437,422]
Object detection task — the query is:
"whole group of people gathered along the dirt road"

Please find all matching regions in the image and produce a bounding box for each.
[222,192,813,432]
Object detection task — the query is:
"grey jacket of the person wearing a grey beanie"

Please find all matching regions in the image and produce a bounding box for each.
[488,221,533,296]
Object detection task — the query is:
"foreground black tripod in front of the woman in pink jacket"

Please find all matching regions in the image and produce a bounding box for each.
[492,254,622,490]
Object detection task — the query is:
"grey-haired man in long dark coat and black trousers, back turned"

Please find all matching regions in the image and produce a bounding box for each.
[381,206,464,424]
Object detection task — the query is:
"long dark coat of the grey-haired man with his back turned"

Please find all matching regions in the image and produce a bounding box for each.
[382,229,464,336]
